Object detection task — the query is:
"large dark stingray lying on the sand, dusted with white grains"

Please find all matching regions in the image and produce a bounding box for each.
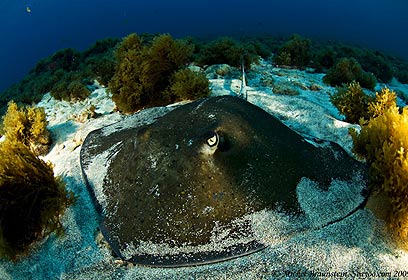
[80,96,366,266]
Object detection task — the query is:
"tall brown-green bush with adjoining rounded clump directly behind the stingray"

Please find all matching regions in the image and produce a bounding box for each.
[108,33,209,113]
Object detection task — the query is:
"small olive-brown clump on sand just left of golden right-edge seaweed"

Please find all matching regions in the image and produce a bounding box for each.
[330,82,373,123]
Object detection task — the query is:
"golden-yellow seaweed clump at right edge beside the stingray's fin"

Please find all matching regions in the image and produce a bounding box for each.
[350,89,408,245]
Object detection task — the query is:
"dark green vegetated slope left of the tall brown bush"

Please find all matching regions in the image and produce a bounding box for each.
[0,38,119,115]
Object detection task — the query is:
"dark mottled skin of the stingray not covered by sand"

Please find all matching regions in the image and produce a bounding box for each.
[79,96,363,264]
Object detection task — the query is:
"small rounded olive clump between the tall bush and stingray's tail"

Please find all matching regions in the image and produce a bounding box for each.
[167,69,210,103]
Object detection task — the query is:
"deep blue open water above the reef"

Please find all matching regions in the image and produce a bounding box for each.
[0,0,408,91]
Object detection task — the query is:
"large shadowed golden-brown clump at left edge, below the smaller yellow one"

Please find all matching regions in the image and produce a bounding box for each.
[0,141,74,260]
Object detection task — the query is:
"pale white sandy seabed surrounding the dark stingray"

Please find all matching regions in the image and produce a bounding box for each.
[0,61,408,280]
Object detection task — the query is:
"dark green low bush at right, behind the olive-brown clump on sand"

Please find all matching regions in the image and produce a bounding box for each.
[323,58,377,90]
